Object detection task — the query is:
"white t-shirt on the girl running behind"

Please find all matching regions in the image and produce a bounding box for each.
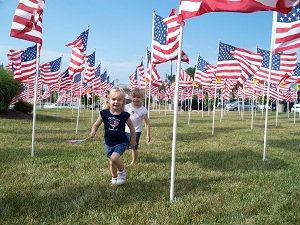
[125,103,147,133]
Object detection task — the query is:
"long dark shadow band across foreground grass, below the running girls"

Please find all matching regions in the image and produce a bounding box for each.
[0,178,222,221]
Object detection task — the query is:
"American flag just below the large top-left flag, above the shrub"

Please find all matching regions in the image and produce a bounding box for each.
[12,45,37,80]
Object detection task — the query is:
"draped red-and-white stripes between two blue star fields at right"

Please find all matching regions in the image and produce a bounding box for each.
[231,45,263,86]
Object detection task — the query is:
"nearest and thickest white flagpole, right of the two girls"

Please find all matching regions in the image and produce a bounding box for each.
[170,19,183,201]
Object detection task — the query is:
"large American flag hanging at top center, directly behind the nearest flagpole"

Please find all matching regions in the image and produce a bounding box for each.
[152,9,189,64]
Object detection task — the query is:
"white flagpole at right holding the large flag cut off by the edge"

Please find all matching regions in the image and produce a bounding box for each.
[263,12,277,161]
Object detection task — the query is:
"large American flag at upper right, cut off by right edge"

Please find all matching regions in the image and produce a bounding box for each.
[274,5,300,53]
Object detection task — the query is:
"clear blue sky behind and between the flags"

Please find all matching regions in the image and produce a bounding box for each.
[0,0,298,84]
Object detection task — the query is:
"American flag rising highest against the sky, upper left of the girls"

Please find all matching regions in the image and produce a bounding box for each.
[66,29,89,76]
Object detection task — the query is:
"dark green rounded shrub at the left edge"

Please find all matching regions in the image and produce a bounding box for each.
[0,69,22,113]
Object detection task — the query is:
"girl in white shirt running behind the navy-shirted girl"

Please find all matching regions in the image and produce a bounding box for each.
[125,88,150,165]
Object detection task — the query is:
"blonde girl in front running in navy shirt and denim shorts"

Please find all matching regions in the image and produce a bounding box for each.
[90,87,136,185]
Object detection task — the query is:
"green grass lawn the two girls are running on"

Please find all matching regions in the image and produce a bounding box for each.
[0,110,300,225]
